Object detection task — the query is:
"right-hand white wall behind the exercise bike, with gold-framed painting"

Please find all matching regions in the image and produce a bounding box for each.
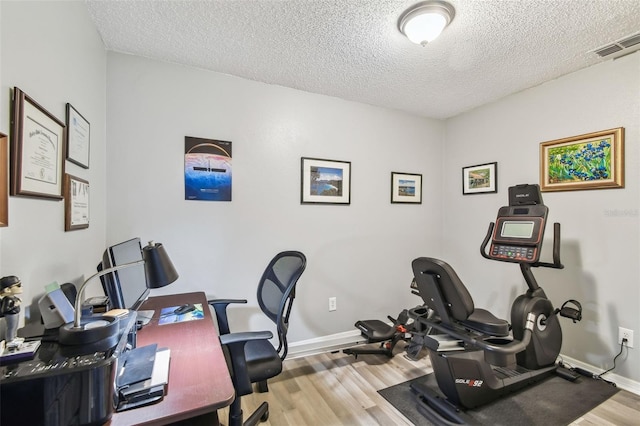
[443,53,640,382]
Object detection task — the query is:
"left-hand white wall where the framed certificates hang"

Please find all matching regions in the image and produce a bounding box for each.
[0,1,106,332]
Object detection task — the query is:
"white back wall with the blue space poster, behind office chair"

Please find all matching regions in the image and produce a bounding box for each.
[107,53,444,342]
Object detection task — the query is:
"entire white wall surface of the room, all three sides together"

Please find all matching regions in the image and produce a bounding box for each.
[0,2,640,388]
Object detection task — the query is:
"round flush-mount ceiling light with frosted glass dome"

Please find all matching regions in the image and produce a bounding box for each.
[398,1,456,46]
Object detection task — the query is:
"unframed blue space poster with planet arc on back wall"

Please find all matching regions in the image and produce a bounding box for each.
[184,136,233,201]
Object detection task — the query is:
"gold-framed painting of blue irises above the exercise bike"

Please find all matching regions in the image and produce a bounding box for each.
[540,127,624,192]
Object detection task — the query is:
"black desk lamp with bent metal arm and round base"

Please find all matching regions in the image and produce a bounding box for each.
[59,241,178,345]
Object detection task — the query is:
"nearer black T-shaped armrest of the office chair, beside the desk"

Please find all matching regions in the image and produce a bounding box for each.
[220,331,273,396]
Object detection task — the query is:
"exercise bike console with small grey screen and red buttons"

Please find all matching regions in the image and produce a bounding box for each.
[488,204,549,263]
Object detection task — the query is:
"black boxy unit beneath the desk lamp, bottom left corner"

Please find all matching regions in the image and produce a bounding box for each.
[0,312,136,426]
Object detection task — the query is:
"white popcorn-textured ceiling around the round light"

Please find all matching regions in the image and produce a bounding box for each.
[86,0,640,118]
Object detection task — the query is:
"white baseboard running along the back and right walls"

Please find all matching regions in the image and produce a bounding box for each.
[287,330,640,395]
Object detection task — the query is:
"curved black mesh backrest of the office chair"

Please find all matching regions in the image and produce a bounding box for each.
[258,251,307,360]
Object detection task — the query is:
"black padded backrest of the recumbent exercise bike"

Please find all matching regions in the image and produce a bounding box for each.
[411,257,475,321]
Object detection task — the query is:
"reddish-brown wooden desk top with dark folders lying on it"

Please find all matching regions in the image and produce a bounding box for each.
[109,292,235,426]
